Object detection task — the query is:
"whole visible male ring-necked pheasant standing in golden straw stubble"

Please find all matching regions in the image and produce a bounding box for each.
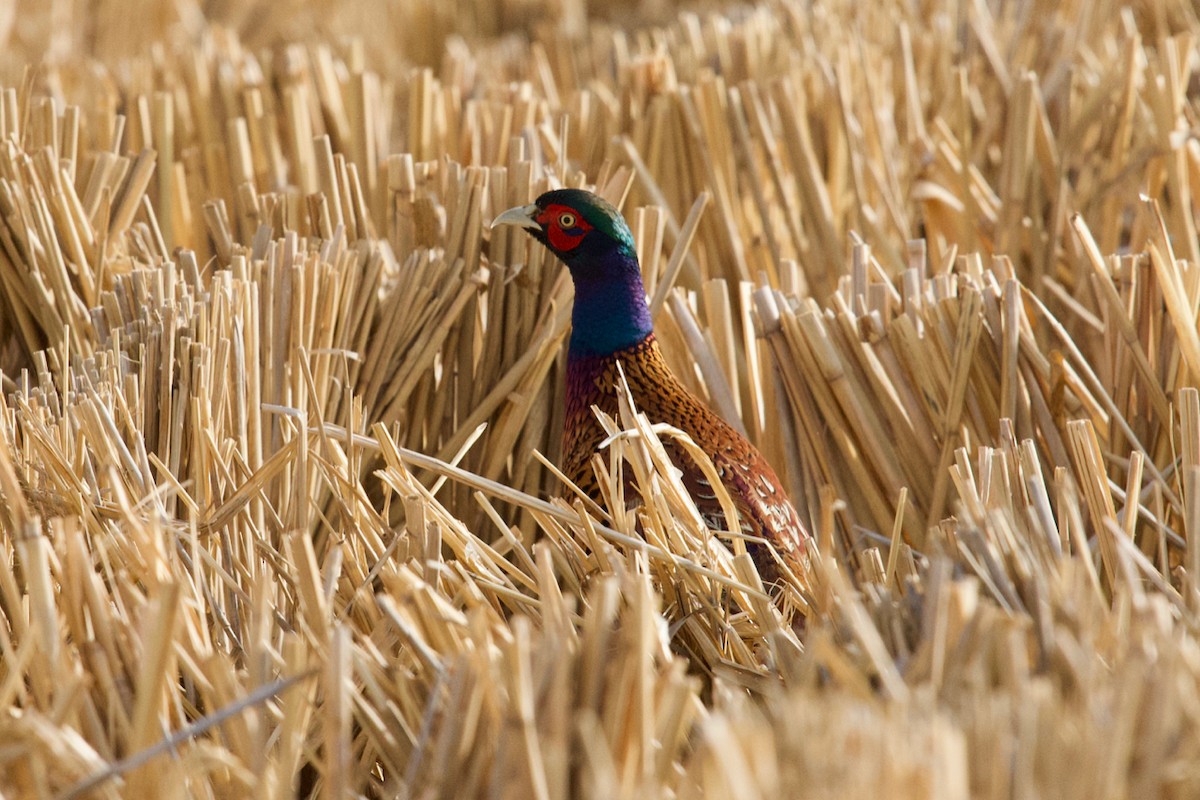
[492,188,809,583]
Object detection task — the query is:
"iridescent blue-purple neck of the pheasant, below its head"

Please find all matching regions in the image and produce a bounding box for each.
[568,248,654,359]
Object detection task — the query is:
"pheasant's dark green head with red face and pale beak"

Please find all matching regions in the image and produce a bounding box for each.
[492,188,637,283]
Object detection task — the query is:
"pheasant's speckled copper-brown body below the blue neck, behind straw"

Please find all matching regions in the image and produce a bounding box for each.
[563,333,805,582]
